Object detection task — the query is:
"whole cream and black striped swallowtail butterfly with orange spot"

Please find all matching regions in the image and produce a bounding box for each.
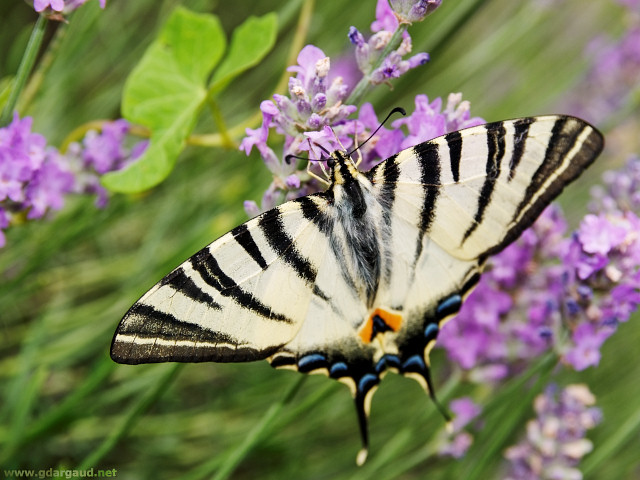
[111,115,604,463]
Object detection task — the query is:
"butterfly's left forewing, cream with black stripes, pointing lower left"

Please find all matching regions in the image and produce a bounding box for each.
[111,195,356,364]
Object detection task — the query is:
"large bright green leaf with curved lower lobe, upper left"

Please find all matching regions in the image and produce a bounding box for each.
[102,7,226,193]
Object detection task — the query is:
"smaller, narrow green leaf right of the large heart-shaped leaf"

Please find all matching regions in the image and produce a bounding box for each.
[209,13,278,95]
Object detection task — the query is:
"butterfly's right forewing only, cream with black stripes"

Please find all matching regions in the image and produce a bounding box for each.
[370,115,603,259]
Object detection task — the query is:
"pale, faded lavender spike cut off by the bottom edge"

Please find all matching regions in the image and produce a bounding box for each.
[504,385,602,480]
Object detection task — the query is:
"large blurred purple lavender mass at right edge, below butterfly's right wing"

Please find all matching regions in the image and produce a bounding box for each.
[439,159,640,382]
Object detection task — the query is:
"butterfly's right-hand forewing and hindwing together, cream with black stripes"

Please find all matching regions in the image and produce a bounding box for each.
[368,116,603,382]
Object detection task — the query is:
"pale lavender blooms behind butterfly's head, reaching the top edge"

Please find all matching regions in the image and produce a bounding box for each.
[240,0,450,216]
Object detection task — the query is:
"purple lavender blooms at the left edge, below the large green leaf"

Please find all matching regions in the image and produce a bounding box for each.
[0,114,146,247]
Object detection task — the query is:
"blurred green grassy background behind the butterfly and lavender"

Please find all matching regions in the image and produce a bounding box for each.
[0,0,640,479]
